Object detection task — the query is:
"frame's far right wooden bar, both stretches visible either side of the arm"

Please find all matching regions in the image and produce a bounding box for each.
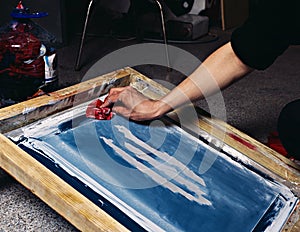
[131,71,300,188]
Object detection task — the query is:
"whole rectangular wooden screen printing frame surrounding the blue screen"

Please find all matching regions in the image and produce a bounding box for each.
[0,68,300,231]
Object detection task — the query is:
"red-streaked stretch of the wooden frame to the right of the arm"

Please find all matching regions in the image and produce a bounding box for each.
[193,112,300,232]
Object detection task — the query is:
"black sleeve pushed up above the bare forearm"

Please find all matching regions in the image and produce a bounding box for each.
[231,0,300,70]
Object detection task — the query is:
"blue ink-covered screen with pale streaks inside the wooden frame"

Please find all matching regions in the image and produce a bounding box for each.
[15,116,297,232]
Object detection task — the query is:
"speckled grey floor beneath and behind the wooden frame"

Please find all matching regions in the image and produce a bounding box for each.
[0,24,300,232]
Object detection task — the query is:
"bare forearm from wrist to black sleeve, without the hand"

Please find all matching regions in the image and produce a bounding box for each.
[157,43,252,114]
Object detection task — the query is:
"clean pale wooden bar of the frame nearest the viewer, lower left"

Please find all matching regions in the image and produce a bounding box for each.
[0,134,127,231]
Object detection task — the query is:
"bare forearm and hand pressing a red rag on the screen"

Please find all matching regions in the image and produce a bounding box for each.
[108,43,251,121]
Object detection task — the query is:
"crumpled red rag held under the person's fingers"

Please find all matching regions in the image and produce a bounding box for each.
[85,99,113,120]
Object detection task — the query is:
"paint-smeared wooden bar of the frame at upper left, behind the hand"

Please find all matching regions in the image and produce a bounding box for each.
[0,68,130,133]
